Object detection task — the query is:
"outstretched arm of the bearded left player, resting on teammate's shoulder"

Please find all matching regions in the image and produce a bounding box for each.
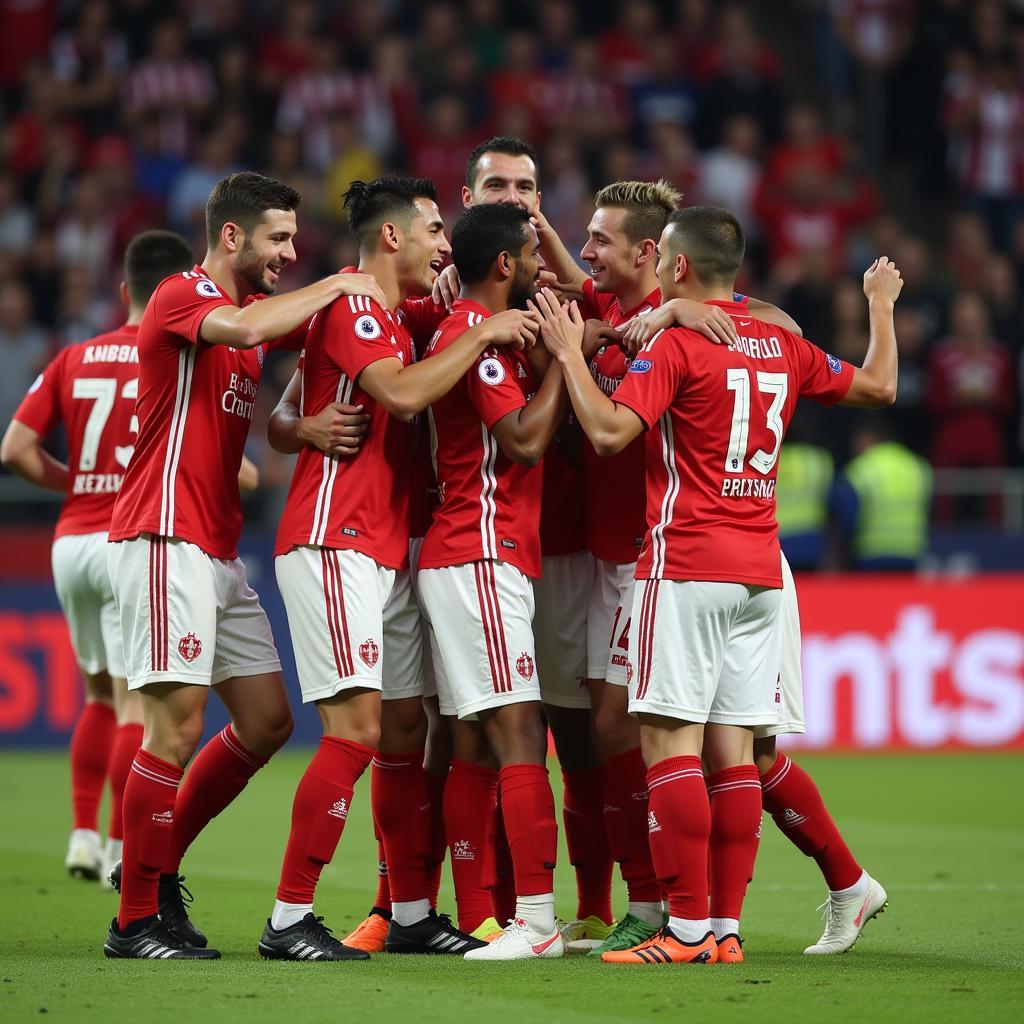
[199,273,384,348]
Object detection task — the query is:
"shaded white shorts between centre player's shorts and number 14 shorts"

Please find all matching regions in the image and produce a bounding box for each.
[534,551,594,709]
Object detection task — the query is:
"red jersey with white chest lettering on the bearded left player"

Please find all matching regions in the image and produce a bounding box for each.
[110,266,276,558]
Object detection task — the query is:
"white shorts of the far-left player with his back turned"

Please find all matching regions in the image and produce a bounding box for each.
[50,532,125,679]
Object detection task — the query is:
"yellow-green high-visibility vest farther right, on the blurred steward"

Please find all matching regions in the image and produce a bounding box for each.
[845,441,932,558]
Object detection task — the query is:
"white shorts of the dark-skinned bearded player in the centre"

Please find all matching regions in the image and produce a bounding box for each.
[417,560,541,719]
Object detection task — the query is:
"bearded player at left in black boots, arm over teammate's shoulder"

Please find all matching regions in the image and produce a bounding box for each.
[103,172,381,959]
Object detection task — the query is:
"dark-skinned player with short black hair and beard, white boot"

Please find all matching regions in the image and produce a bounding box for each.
[419,204,567,961]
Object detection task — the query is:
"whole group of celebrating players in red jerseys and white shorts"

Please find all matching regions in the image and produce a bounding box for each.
[2,137,901,966]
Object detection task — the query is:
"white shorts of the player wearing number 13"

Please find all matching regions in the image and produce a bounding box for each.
[630,580,782,726]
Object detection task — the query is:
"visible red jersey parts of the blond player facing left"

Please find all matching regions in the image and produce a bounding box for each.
[581,279,662,564]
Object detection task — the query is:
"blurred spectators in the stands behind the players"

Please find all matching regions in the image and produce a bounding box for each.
[0,0,1024,565]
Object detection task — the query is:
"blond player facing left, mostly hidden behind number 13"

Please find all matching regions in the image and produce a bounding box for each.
[542,181,796,956]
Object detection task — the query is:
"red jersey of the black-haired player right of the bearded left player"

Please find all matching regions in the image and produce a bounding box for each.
[274,282,416,569]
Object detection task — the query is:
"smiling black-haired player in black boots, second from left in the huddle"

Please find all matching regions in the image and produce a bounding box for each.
[259,177,536,959]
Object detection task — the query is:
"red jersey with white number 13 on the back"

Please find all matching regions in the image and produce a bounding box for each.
[614,302,853,587]
